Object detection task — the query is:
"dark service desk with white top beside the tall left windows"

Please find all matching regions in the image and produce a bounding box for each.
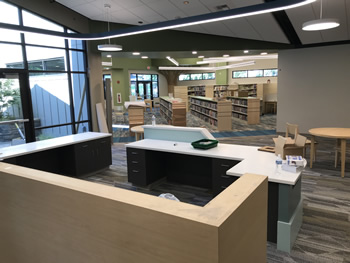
[0,132,112,177]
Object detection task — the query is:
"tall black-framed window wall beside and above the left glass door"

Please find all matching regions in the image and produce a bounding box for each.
[0,1,91,140]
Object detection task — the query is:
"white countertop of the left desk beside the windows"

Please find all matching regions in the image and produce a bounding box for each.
[0,132,111,160]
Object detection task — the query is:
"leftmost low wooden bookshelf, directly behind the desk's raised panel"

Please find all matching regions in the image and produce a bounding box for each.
[160,97,186,126]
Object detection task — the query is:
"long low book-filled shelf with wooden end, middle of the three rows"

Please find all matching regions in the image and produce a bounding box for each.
[190,96,232,131]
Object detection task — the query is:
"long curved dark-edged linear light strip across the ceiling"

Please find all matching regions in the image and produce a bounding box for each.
[0,0,316,40]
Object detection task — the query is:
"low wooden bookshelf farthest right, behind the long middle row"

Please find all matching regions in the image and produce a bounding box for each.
[227,97,260,124]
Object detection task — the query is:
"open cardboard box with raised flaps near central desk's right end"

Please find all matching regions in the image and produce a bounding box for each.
[275,134,307,159]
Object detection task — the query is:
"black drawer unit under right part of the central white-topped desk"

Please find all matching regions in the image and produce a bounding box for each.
[212,159,239,196]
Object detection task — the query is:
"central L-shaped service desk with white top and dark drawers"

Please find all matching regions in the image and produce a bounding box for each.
[126,139,302,252]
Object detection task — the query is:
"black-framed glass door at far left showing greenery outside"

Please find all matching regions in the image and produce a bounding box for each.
[0,72,29,148]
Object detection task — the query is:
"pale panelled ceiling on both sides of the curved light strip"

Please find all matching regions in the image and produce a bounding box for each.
[56,0,350,58]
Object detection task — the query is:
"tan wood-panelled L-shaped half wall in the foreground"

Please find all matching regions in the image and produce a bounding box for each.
[0,163,267,263]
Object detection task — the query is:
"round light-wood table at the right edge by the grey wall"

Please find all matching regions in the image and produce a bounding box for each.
[309,128,350,177]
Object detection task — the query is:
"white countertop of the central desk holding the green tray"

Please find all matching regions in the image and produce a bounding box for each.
[126,139,301,185]
